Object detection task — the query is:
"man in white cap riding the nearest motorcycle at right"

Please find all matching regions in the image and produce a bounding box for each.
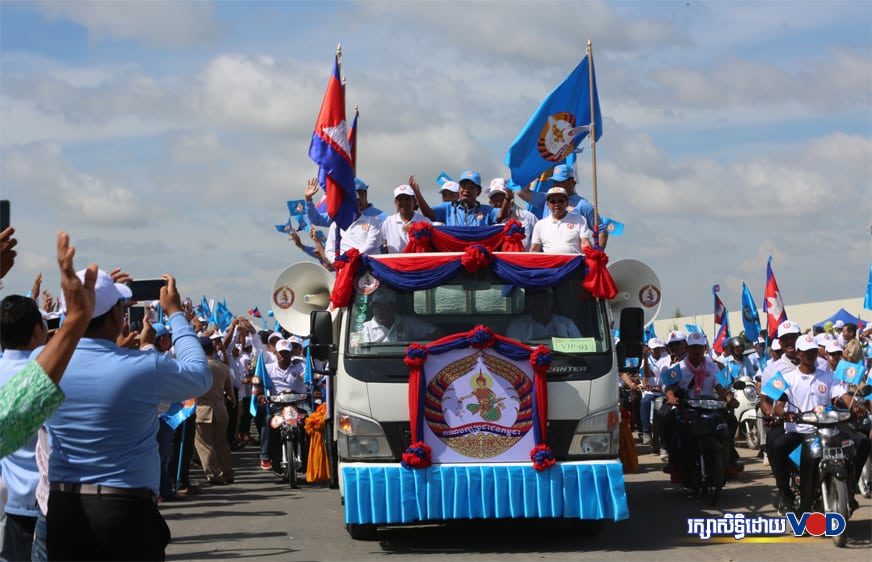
[767,332,869,513]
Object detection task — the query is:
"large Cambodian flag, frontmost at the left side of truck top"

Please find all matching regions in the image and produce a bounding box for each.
[309,56,358,229]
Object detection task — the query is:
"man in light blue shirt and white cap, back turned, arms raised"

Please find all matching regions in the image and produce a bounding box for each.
[46,271,212,560]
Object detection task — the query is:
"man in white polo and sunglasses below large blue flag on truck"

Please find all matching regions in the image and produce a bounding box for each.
[530,187,593,254]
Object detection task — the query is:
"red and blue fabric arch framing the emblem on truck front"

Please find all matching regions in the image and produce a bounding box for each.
[402,325,557,471]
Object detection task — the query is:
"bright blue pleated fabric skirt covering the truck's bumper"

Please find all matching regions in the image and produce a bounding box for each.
[342,461,630,524]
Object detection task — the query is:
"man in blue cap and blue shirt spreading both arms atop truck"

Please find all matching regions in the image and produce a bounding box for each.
[409,170,512,226]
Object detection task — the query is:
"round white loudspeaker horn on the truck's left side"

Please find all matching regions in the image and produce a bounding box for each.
[270,262,333,336]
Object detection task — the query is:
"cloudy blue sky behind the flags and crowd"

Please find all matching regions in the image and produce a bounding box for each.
[0,1,872,324]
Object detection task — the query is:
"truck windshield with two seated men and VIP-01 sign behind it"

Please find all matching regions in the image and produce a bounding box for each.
[347,271,611,356]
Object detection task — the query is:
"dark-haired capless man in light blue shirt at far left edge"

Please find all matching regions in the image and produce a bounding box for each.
[0,295,48,560]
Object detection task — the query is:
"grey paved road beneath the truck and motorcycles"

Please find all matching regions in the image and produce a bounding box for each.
[161,448,872,562]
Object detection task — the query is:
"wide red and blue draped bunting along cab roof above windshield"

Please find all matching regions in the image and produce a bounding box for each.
[330,244,617,307]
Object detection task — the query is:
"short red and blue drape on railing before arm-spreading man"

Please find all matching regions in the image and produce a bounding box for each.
[403,219,526,254]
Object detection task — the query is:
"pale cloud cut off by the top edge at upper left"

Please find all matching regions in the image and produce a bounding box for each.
[38,0,219,47]
